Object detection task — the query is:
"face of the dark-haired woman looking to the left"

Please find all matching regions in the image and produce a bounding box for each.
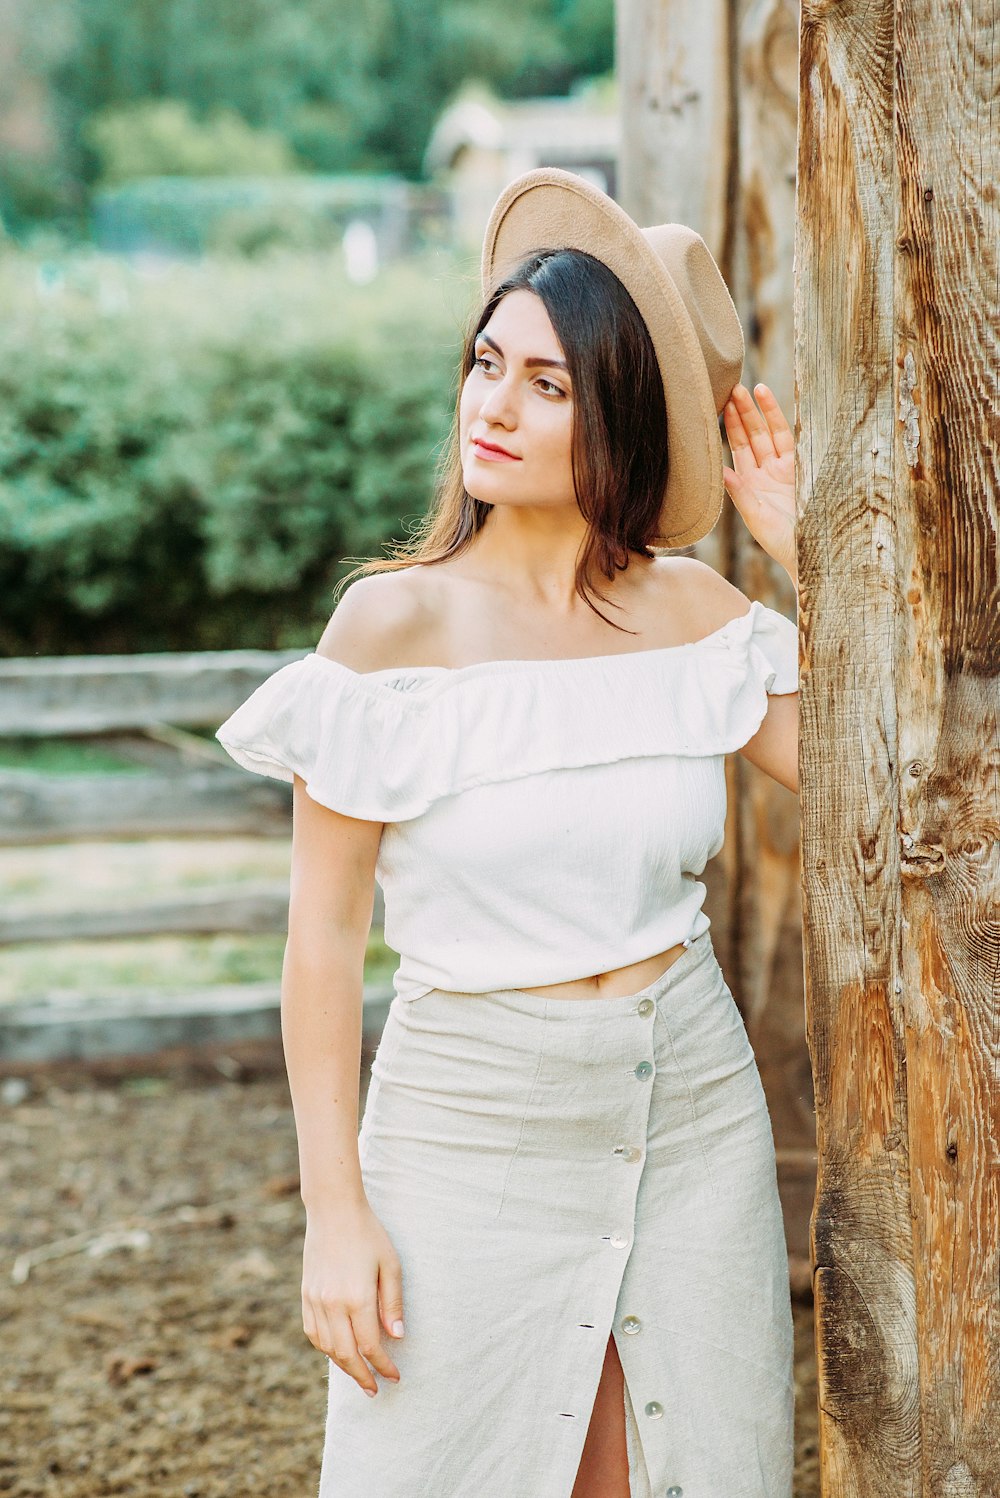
[458,291,576,508]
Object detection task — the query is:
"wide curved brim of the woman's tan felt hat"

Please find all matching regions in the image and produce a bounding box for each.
[482,168,725,548]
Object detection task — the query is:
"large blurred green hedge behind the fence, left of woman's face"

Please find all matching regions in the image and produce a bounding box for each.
[0,253,475,655]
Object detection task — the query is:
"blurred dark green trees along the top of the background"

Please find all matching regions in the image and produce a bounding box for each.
[0,0,614,222]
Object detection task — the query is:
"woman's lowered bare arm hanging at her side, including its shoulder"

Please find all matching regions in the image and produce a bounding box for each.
[281,580,431,1395]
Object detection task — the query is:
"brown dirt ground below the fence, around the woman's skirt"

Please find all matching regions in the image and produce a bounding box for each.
[0,1047,819,1498]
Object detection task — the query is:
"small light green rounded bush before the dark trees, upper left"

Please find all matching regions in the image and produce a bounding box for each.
[84,99,298,186]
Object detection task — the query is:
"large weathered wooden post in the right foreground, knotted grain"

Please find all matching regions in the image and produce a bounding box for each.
[795,0,1000,1498]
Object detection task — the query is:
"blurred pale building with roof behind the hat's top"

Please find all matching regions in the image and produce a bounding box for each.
[424,79,621,250]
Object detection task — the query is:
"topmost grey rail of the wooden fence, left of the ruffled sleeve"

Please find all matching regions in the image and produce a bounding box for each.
[0,650,307,739]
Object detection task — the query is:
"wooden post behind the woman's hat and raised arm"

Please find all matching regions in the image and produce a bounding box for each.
[617,0,816,1258]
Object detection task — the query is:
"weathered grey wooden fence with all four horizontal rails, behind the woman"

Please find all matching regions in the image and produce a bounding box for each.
[0,650,392,1071]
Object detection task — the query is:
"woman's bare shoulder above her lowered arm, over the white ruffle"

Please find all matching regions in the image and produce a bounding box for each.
[316,566,439,671]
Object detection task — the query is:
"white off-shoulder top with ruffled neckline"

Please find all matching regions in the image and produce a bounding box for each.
[216,601,798,999]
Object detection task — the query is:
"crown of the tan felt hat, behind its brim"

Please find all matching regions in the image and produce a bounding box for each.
[641,223,746,412]
